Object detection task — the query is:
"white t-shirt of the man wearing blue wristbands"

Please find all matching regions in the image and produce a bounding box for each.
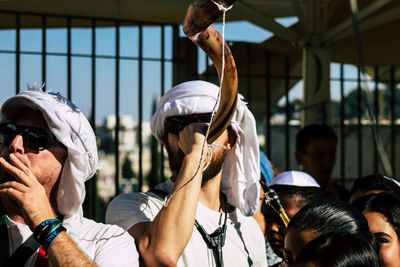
[7,215,139,267]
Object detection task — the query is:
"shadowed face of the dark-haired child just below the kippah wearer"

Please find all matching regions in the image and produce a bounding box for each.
[283,229,317,267]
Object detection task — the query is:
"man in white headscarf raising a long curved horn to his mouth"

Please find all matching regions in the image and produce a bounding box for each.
[106,81,267,266]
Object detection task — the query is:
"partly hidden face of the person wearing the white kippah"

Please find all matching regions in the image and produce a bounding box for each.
[264,195,301,258]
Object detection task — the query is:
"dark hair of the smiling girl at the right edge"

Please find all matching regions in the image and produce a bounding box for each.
[353,193,400,238]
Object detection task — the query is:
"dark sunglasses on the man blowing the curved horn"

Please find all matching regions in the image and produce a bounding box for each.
[165,113,211,135]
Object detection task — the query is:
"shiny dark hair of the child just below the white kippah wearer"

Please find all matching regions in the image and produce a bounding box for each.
[287,200,373,241]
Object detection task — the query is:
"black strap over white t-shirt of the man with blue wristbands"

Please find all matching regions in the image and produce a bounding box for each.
[0,201,40,267]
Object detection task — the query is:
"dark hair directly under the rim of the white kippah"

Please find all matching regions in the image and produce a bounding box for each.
[270,185,322,208]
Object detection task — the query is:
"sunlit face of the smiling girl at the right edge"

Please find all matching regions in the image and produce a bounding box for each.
[363,212,400,267]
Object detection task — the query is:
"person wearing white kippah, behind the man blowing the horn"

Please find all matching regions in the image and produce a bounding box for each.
[263,171,321,267]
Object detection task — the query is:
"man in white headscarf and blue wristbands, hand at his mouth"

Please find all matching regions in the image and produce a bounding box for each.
[0,87,138,266]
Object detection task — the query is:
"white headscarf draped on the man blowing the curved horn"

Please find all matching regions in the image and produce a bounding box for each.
[151,81,260,216]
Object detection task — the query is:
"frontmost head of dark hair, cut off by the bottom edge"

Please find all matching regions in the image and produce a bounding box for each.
[294,233,382,267]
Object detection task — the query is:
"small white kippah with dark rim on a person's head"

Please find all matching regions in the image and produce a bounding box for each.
[268,171,320,188]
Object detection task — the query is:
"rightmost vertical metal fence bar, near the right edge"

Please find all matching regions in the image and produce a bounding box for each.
[390,66,396,177]
